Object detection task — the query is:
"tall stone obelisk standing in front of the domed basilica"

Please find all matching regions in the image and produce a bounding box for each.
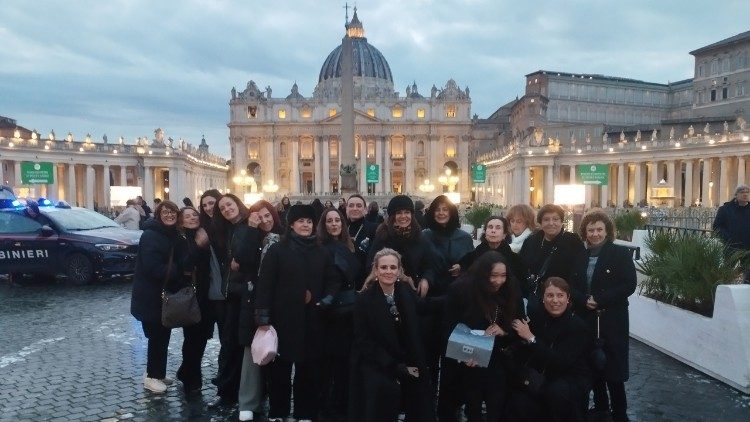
[339,12,364,195]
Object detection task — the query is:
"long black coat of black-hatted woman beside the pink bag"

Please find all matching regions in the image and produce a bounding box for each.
[255,234,341,362]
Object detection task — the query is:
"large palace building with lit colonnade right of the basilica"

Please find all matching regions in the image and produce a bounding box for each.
[472,31,750,206]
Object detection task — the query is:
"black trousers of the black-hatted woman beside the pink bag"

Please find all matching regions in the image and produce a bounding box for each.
[268,357,320,420]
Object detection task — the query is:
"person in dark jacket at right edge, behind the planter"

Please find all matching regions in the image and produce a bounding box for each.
[713,184,750,283]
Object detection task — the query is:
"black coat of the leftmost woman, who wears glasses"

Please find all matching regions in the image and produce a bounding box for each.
[130,220,190,322]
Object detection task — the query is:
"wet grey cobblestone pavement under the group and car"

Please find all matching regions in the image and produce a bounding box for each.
[0,278,750,421]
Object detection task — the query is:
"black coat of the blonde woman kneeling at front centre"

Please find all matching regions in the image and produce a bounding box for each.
[349,282,434,422]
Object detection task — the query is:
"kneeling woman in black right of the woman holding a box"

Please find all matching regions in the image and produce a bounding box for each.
[509,277,592,422]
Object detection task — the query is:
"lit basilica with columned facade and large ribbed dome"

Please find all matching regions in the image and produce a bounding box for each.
[229,9,472,197]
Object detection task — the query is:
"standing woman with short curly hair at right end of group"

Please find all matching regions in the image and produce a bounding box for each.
[573,211,636,422]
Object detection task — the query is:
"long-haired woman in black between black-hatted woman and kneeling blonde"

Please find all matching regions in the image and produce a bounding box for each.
[317,207,361,419]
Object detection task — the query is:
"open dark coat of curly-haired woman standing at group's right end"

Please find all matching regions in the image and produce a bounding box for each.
[571,242,636,382]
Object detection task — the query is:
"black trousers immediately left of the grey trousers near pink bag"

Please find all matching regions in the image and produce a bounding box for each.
[215,296,245,401]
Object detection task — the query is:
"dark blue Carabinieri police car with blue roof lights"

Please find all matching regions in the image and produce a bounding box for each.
[0,197,141,284]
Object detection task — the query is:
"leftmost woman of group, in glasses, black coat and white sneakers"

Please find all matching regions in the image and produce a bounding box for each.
[130,201,189,393]
